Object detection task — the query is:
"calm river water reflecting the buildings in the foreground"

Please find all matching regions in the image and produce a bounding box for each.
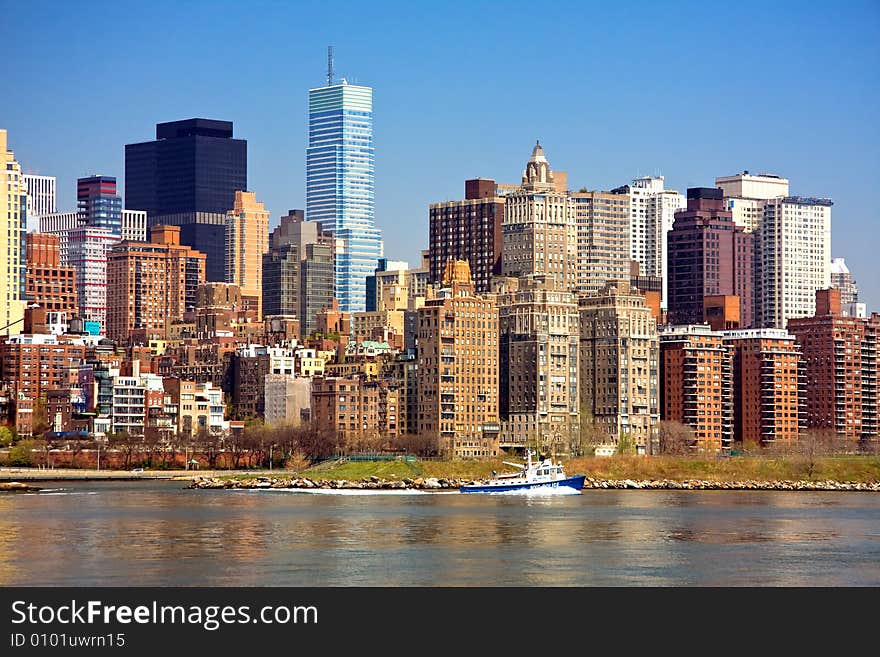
[0,481,880,586]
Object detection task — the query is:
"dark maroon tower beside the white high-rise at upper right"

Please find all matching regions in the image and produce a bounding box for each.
[667,187,754,327]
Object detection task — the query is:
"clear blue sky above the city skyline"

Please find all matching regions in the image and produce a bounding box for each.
[0,0,880,310]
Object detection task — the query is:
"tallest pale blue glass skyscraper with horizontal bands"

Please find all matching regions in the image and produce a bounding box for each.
[306,81,382,312]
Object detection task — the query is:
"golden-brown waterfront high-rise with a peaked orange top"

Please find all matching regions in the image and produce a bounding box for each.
[417,260,501,458]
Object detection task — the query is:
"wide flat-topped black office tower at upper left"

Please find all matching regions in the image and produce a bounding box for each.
[125,119,248,281]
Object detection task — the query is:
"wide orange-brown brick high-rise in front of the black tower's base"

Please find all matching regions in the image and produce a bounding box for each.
[107,226,205,343]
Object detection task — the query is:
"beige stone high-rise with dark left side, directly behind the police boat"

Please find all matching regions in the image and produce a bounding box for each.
[497,277,580,453]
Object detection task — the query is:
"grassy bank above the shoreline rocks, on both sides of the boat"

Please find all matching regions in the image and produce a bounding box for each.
[299,456,880,483]
